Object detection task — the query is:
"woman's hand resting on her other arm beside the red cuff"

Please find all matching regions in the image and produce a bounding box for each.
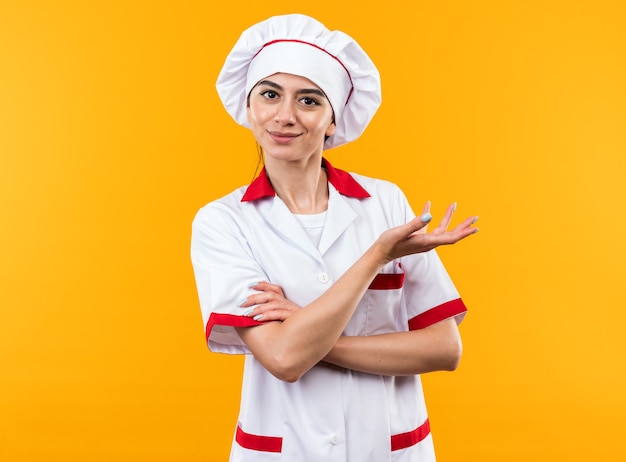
[240,281,301,322]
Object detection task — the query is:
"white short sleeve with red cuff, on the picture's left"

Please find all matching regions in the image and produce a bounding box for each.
[191,204,267,354]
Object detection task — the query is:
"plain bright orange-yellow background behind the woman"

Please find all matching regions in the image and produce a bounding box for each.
[0,0,626,462]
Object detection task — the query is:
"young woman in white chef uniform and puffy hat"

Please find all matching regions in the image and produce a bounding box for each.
[191,15,477,462]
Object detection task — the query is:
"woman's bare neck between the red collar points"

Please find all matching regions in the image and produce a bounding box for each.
[265,155,328,214]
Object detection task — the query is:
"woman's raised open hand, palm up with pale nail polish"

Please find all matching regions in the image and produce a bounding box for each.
[375,202,478,262]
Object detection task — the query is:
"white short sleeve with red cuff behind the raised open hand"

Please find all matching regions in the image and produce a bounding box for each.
[398,187,467,330]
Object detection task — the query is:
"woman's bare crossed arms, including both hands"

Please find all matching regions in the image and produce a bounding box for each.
[237,205,476,382]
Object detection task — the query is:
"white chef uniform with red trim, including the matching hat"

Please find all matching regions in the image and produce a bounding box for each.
[191,15,466,462]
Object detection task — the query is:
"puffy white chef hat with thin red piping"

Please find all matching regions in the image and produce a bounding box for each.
[216,14,381,149]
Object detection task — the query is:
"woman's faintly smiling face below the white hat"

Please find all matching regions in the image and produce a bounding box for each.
[247,73,335,160]
